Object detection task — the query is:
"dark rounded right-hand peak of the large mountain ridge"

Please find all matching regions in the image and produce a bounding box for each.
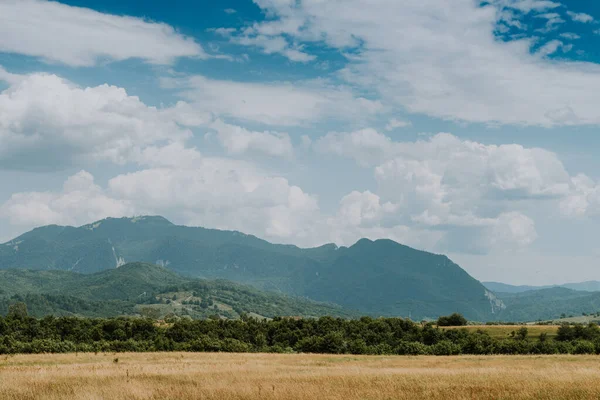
[307,239,499,320]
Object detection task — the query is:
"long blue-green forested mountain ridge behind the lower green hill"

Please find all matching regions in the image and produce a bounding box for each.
[0,217,503,320]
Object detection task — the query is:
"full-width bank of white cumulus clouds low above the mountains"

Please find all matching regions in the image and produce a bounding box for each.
[0,127,576,253]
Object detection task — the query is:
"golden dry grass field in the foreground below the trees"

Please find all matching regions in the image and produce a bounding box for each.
[0,353,600,400]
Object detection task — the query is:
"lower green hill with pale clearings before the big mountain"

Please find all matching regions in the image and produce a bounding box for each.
[0,263,358,318]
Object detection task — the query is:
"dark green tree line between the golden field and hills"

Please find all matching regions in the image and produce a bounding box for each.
[0,305,600,355]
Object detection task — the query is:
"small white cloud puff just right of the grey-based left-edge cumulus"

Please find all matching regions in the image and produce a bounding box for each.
[210,120,294,157]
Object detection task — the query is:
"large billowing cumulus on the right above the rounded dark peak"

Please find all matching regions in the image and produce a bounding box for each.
[314,129,589,252]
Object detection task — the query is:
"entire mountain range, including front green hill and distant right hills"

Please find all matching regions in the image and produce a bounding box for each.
[0,216,600,321]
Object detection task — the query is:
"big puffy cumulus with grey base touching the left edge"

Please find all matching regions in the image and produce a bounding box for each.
[0,70,202,169]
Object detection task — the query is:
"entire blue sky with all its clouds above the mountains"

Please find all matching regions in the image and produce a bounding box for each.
[0,0,600,284]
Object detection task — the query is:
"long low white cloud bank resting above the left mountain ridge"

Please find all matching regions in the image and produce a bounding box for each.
[0,162,319,245]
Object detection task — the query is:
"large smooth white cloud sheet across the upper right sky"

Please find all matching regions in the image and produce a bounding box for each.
[239,0,600,126]
